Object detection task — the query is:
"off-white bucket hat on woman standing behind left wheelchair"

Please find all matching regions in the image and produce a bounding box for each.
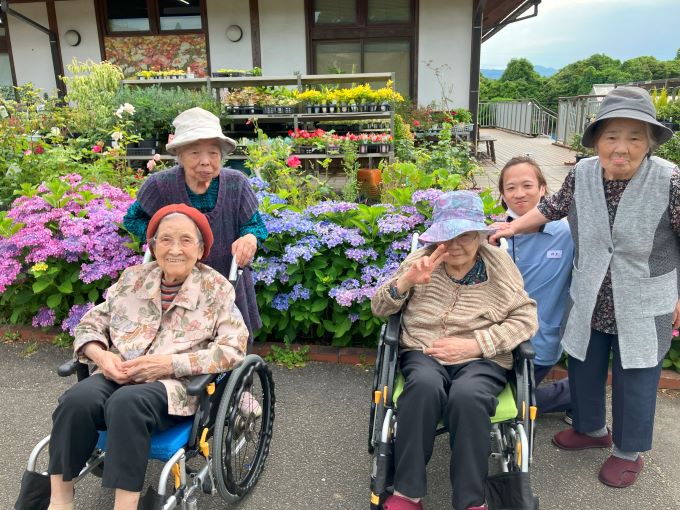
[165,107,236,156]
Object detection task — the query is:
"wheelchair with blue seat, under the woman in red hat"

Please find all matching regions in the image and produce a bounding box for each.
[16,258,276,510]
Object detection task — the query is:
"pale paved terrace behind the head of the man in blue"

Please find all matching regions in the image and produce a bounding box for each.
[475,129,576,192]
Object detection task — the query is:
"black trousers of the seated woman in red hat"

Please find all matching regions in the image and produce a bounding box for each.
[48,374,184,492]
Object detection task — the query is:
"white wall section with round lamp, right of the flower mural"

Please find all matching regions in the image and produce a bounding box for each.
[206,0,254,71]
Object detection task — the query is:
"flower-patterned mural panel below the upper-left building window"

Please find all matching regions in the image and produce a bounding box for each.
[104,34,208,77]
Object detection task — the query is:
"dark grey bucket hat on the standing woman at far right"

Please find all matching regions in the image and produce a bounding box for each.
[581,87,673,148]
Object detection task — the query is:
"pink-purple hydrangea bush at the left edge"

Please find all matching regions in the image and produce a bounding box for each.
[0,174,142,334]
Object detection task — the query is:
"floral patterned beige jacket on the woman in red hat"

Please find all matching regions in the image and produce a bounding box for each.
[73,262,248,416]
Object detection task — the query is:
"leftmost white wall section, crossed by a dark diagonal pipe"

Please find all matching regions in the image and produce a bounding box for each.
[7,2,57,94]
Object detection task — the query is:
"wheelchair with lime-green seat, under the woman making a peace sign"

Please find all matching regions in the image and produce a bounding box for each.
[368,234,538,510]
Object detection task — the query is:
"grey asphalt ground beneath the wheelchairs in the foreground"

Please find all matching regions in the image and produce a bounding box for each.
[0,343,680,510]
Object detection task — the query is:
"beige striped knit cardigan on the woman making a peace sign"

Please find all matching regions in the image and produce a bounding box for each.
[371,242,538,368]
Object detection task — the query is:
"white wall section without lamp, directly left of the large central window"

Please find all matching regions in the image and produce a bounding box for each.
[259,0,307,76]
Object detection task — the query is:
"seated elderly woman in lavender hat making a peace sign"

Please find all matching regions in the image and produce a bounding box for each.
[369,191,537,510]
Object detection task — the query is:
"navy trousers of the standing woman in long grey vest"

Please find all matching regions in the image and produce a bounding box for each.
[569,329,663,452]
